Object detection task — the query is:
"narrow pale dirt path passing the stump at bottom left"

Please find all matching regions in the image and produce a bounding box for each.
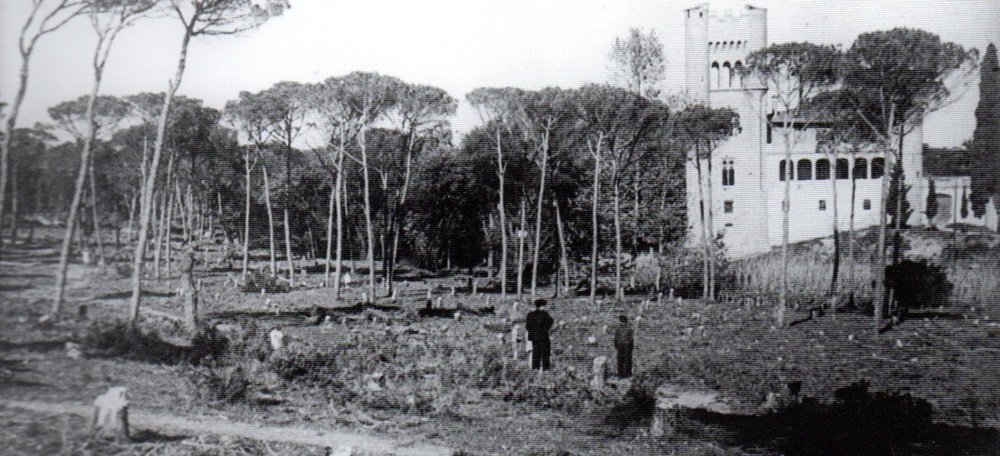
[0,399,453,456]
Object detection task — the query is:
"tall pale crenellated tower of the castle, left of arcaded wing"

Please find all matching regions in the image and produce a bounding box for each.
[685,4,769,257]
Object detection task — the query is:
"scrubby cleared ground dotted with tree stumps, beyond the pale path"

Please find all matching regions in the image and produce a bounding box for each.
[2,230,1000,454]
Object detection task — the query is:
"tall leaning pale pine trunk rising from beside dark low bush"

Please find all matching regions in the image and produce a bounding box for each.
[129,24,193,329]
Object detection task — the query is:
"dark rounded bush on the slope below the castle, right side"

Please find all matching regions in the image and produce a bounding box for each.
[885,260,952,310]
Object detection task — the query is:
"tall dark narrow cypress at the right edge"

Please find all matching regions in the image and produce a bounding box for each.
[970,43,1000,216]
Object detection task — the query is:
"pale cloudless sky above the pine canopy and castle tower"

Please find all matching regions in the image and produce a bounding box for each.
[0,0,1000,147]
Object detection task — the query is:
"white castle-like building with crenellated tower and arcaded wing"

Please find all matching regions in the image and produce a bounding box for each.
[685,4,985,258]
